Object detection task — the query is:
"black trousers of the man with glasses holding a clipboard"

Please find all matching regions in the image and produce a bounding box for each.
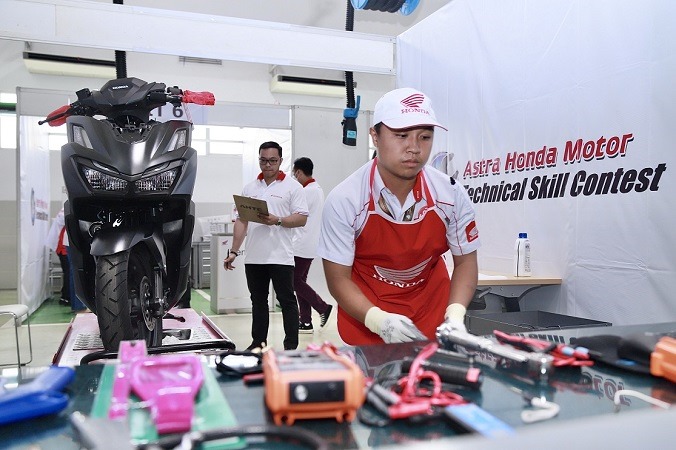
[244,264,298,350]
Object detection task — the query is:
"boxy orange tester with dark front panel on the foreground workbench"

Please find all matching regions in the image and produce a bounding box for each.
[263,346,365,425]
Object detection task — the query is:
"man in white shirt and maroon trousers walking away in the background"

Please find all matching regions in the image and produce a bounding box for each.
[292,157,333,334]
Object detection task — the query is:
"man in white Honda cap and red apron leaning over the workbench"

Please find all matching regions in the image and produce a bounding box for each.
[317,88,480,345]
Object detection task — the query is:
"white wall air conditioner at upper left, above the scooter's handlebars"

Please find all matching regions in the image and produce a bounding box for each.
[23,52,117,80]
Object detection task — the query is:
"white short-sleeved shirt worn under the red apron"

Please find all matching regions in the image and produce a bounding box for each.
[317,161,481,266]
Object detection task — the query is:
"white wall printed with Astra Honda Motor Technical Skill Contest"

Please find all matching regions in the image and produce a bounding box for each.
[397,0,676,325]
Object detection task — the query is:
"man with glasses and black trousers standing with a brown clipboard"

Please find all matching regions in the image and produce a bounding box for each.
[223,141,308,350]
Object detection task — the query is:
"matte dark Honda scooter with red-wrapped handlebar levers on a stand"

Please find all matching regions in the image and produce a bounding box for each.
[40,78,214,351]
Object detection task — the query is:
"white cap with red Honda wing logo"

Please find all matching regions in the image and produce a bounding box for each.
[373,88,448,131]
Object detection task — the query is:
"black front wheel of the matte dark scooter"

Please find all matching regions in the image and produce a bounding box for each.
[95,246,162,351]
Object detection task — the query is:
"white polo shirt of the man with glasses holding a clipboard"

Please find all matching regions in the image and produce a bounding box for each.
[242,172,308,266]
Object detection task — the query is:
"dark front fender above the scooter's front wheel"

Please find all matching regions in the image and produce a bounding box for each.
[89,228,167,273]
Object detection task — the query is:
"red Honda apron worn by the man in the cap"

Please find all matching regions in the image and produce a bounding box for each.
[338,161,451,345]
